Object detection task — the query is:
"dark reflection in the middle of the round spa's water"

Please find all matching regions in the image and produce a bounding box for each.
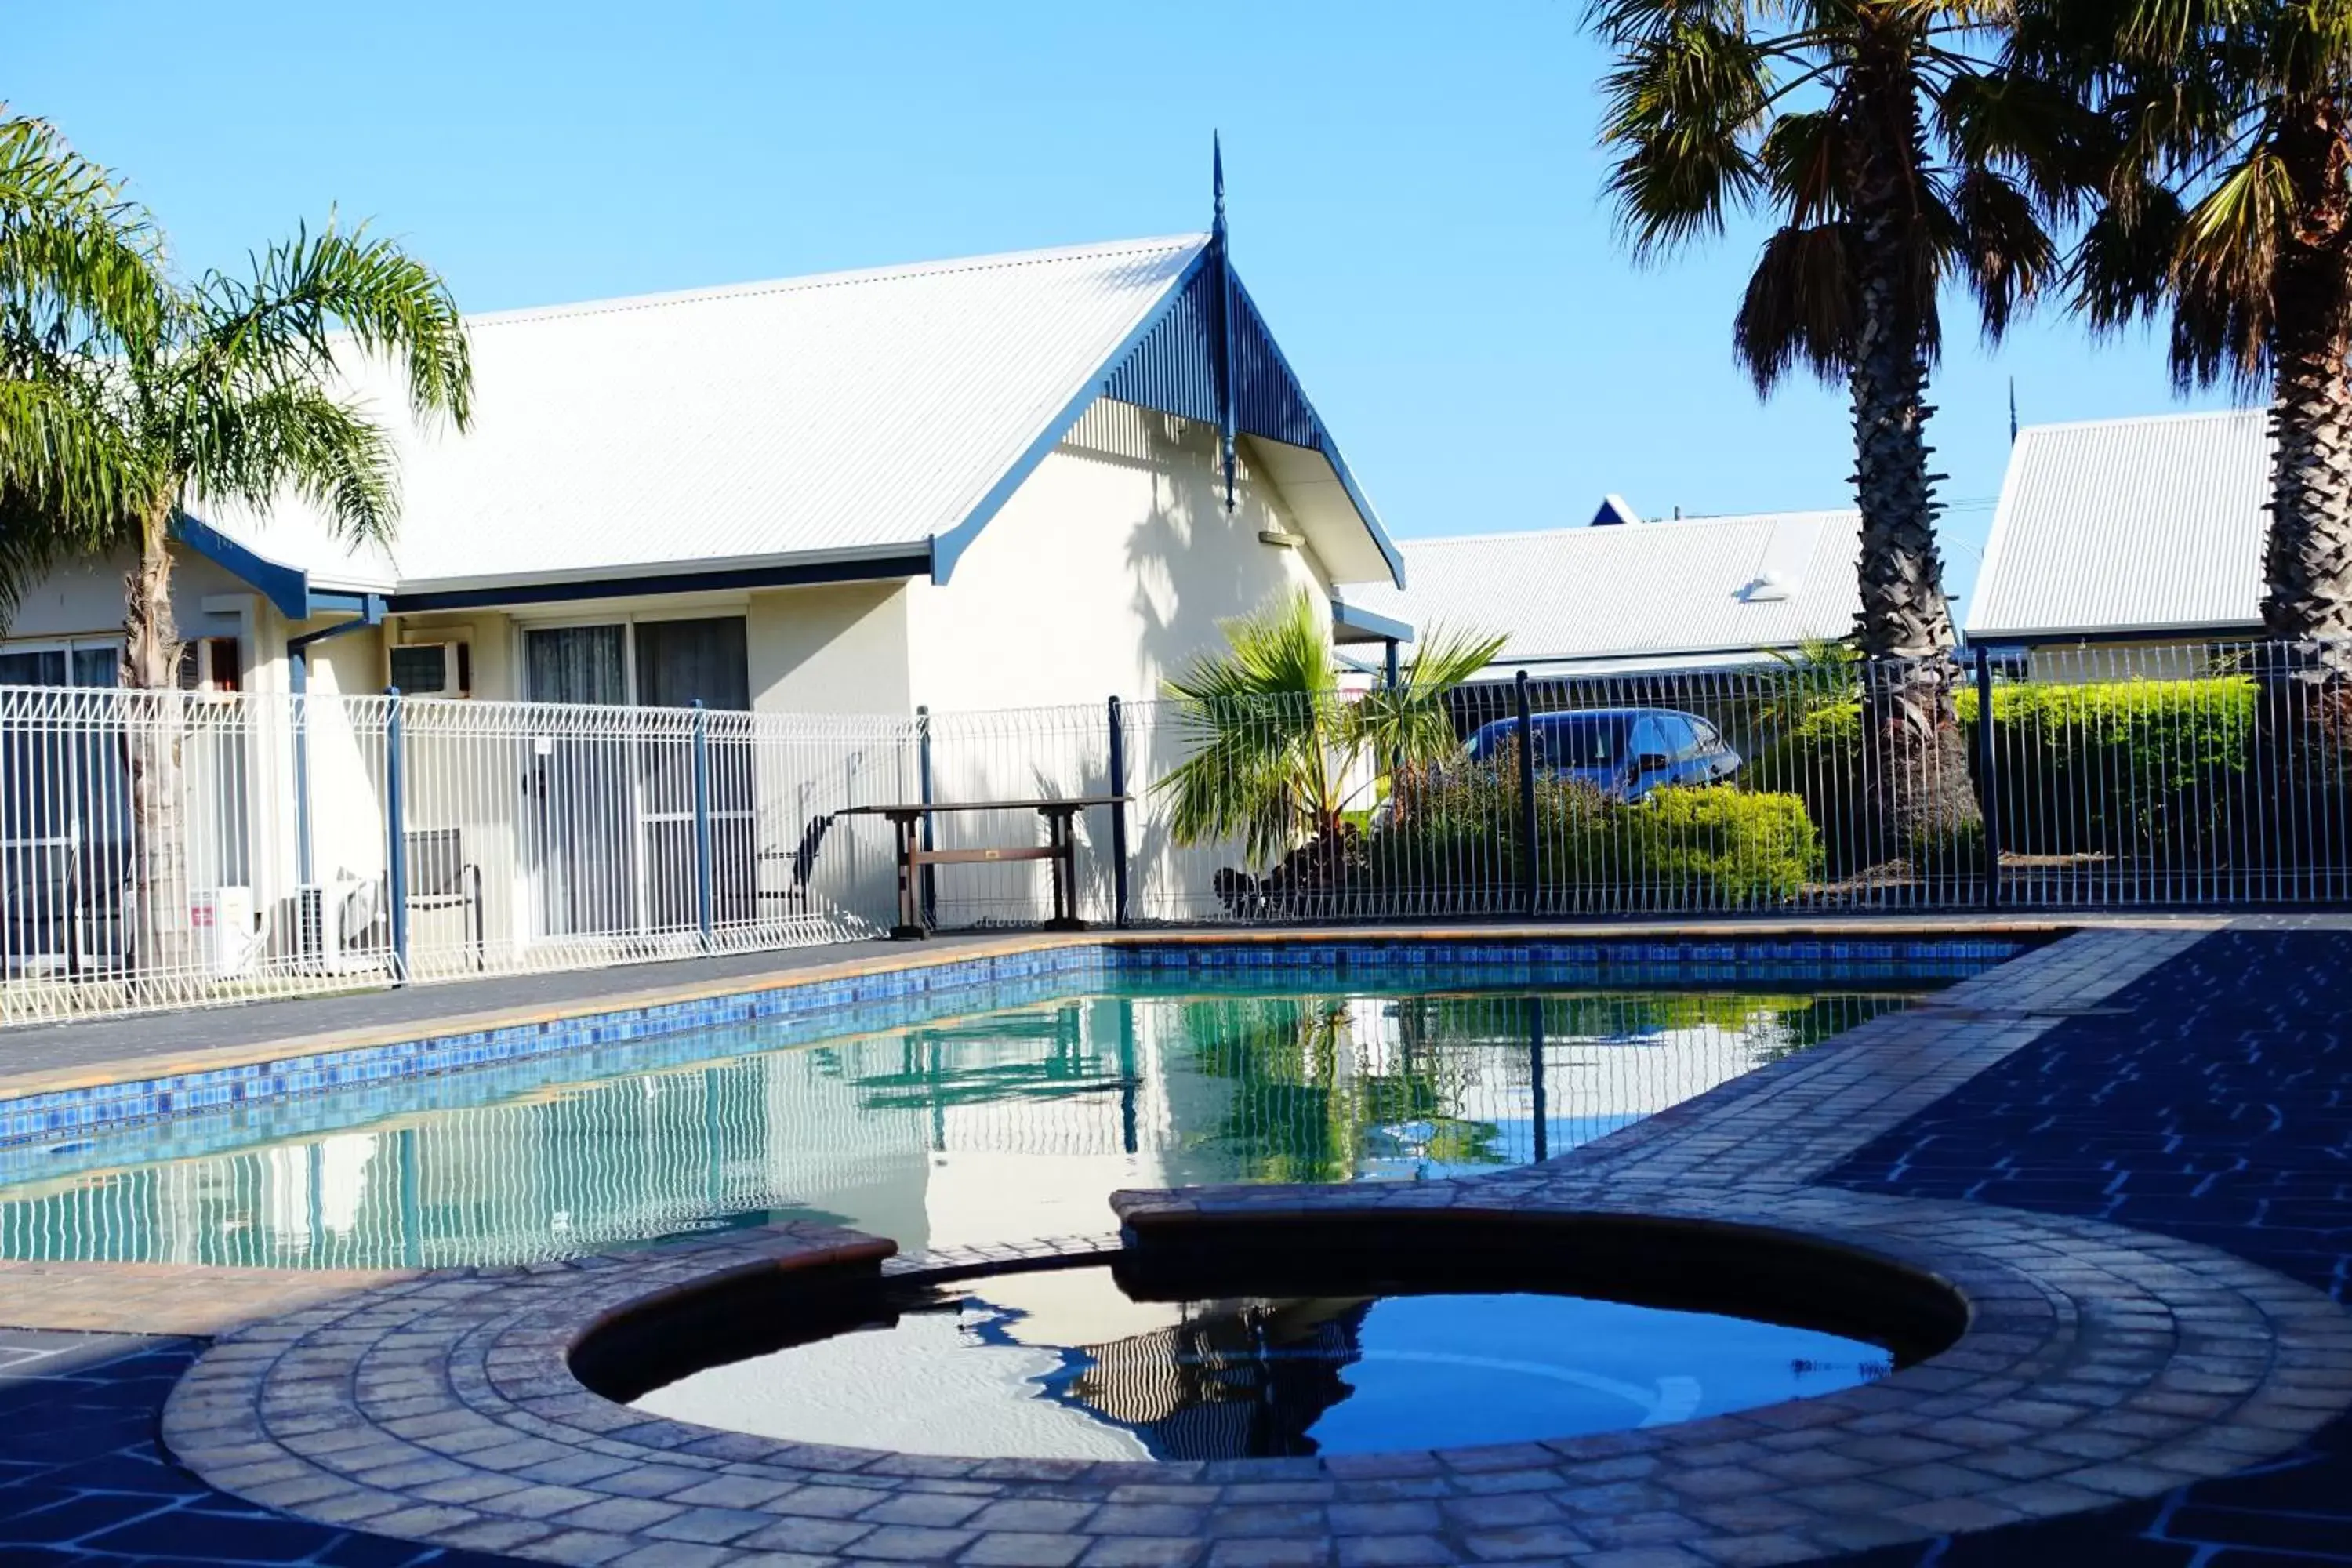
[1049,1298,1371,1460]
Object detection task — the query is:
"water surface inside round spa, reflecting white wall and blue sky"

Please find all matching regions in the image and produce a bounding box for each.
[635,1267,1891,1460]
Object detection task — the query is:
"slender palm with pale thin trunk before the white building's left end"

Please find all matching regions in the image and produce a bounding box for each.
[38,223,473,971]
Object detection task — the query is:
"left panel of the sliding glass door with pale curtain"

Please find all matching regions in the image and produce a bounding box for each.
[522,626,640,935]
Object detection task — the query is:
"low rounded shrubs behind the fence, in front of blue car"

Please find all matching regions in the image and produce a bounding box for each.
[1367,767,1820,907]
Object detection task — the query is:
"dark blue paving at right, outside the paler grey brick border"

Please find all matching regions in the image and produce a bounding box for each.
[1828,928,2352,1568]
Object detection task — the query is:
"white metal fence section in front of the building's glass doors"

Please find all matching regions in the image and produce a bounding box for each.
[0,687,917,1022]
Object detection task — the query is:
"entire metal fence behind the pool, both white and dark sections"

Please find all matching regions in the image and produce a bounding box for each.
[0,644,2352,1022]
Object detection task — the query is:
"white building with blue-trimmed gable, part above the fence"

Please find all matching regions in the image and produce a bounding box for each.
[0,235,1402,715]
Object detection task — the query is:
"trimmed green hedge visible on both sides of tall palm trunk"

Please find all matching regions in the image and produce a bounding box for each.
[1740,677,2258,872]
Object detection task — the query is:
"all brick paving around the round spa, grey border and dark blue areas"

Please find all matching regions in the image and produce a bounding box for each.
[13,926,2352,1568]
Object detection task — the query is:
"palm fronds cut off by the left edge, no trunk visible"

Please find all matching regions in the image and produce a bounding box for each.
[0,108,158,628]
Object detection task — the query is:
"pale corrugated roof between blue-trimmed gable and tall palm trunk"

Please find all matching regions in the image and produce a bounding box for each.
[1345,513,1860,668]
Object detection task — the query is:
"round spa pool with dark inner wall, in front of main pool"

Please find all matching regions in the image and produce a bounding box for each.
[572,1208,1969,1460]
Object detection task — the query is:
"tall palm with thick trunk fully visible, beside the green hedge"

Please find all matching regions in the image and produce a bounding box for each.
[1590,0,2065,846]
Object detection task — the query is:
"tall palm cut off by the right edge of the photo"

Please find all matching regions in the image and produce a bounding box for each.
[2016,0,2352,648]
